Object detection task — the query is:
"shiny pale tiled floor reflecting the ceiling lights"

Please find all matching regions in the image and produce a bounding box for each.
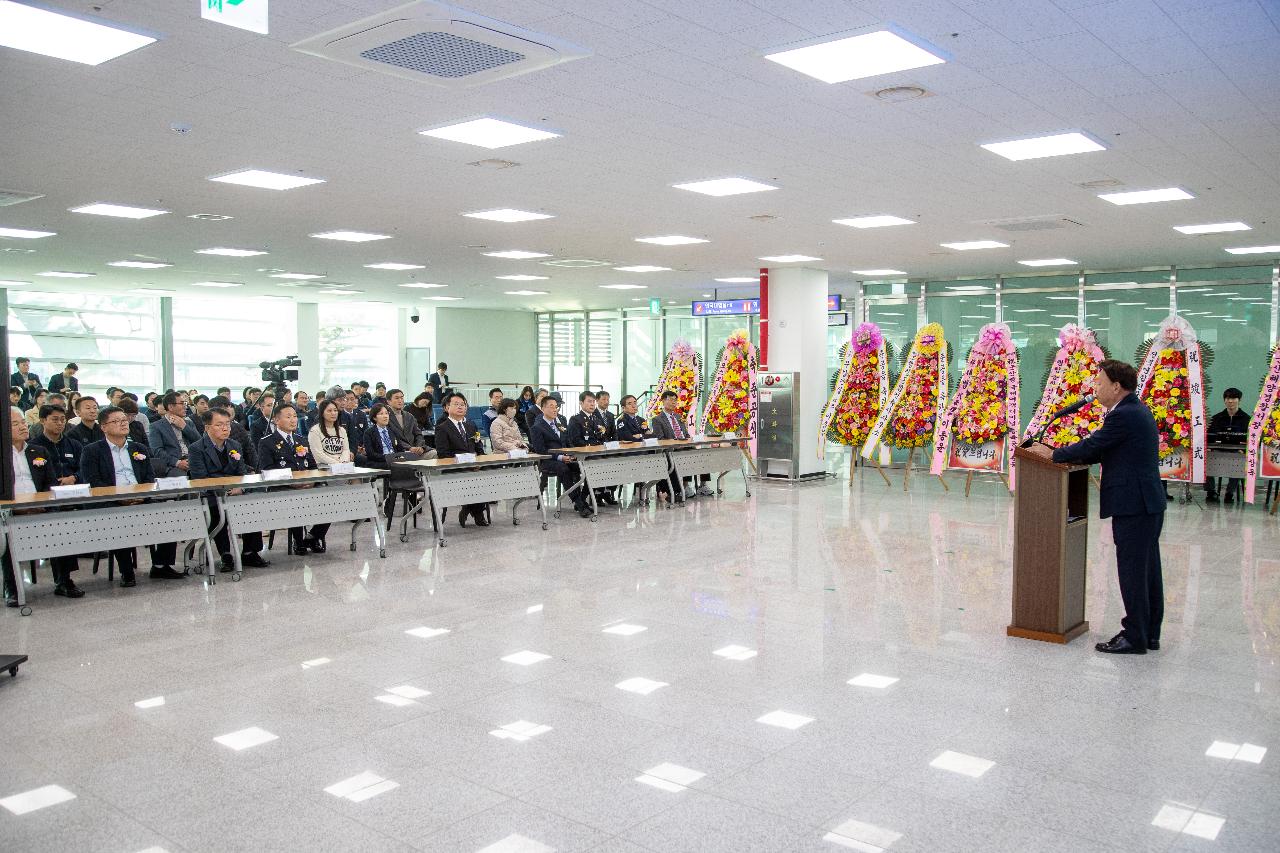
[0,460,1280,853]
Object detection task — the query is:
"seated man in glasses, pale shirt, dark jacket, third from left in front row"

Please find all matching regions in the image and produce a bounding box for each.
[79,406,186,587]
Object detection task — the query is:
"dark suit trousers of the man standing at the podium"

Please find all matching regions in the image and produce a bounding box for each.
[1111,512,1165,648]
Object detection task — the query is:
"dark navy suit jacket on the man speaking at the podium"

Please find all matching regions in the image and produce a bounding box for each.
[1053,393,1165,519]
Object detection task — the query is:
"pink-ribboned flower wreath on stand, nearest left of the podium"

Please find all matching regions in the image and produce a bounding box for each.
[929,323,1018,497]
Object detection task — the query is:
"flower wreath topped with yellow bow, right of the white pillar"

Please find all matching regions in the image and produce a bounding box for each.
[863,323,947,459]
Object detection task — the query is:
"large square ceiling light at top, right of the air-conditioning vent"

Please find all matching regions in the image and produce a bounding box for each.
[764,26,948,83]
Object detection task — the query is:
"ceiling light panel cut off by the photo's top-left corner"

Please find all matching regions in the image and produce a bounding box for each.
[0,0,157,65]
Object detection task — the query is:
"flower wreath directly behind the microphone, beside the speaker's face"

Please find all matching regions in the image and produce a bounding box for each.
[1027,323,1106,447]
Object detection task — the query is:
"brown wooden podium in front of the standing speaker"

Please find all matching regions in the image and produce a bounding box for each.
[1006,448,1089,643]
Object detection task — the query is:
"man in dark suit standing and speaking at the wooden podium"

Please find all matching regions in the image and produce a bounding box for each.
[1029,359,1165,654]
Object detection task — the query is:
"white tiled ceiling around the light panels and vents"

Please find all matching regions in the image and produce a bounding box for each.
[0,0,1280,309]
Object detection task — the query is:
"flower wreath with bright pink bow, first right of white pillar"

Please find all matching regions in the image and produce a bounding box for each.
[818,323,890,457]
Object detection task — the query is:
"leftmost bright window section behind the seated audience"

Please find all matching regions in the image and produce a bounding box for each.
[8,289,161,400]
